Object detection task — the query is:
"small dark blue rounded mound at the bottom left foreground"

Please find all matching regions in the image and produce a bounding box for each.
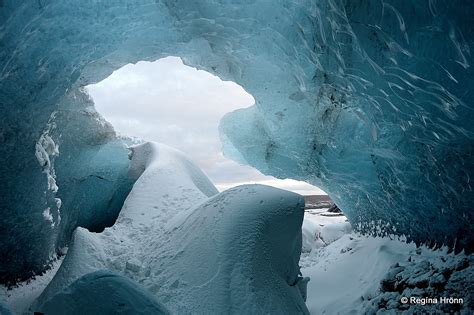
[41,270,169,315]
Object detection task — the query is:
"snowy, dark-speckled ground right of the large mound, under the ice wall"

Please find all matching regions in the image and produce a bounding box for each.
[300,209,474,314]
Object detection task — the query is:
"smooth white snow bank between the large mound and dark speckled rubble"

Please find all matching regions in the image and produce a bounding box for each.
[301,233,416,314]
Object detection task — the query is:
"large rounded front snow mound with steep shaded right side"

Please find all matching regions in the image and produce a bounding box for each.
[144,185,307,314]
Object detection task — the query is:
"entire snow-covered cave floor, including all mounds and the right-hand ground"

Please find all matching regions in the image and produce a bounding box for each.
[0,147,474,315]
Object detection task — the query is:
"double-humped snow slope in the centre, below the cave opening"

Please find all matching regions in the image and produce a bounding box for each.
[31,143,308,314]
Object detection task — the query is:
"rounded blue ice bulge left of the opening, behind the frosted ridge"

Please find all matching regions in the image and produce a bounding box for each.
[52,91,137,247]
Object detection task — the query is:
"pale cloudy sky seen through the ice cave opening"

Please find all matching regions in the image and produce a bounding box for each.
[86,57,325,195]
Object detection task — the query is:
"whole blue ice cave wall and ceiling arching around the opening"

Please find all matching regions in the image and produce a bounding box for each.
[0,0,474,282]
